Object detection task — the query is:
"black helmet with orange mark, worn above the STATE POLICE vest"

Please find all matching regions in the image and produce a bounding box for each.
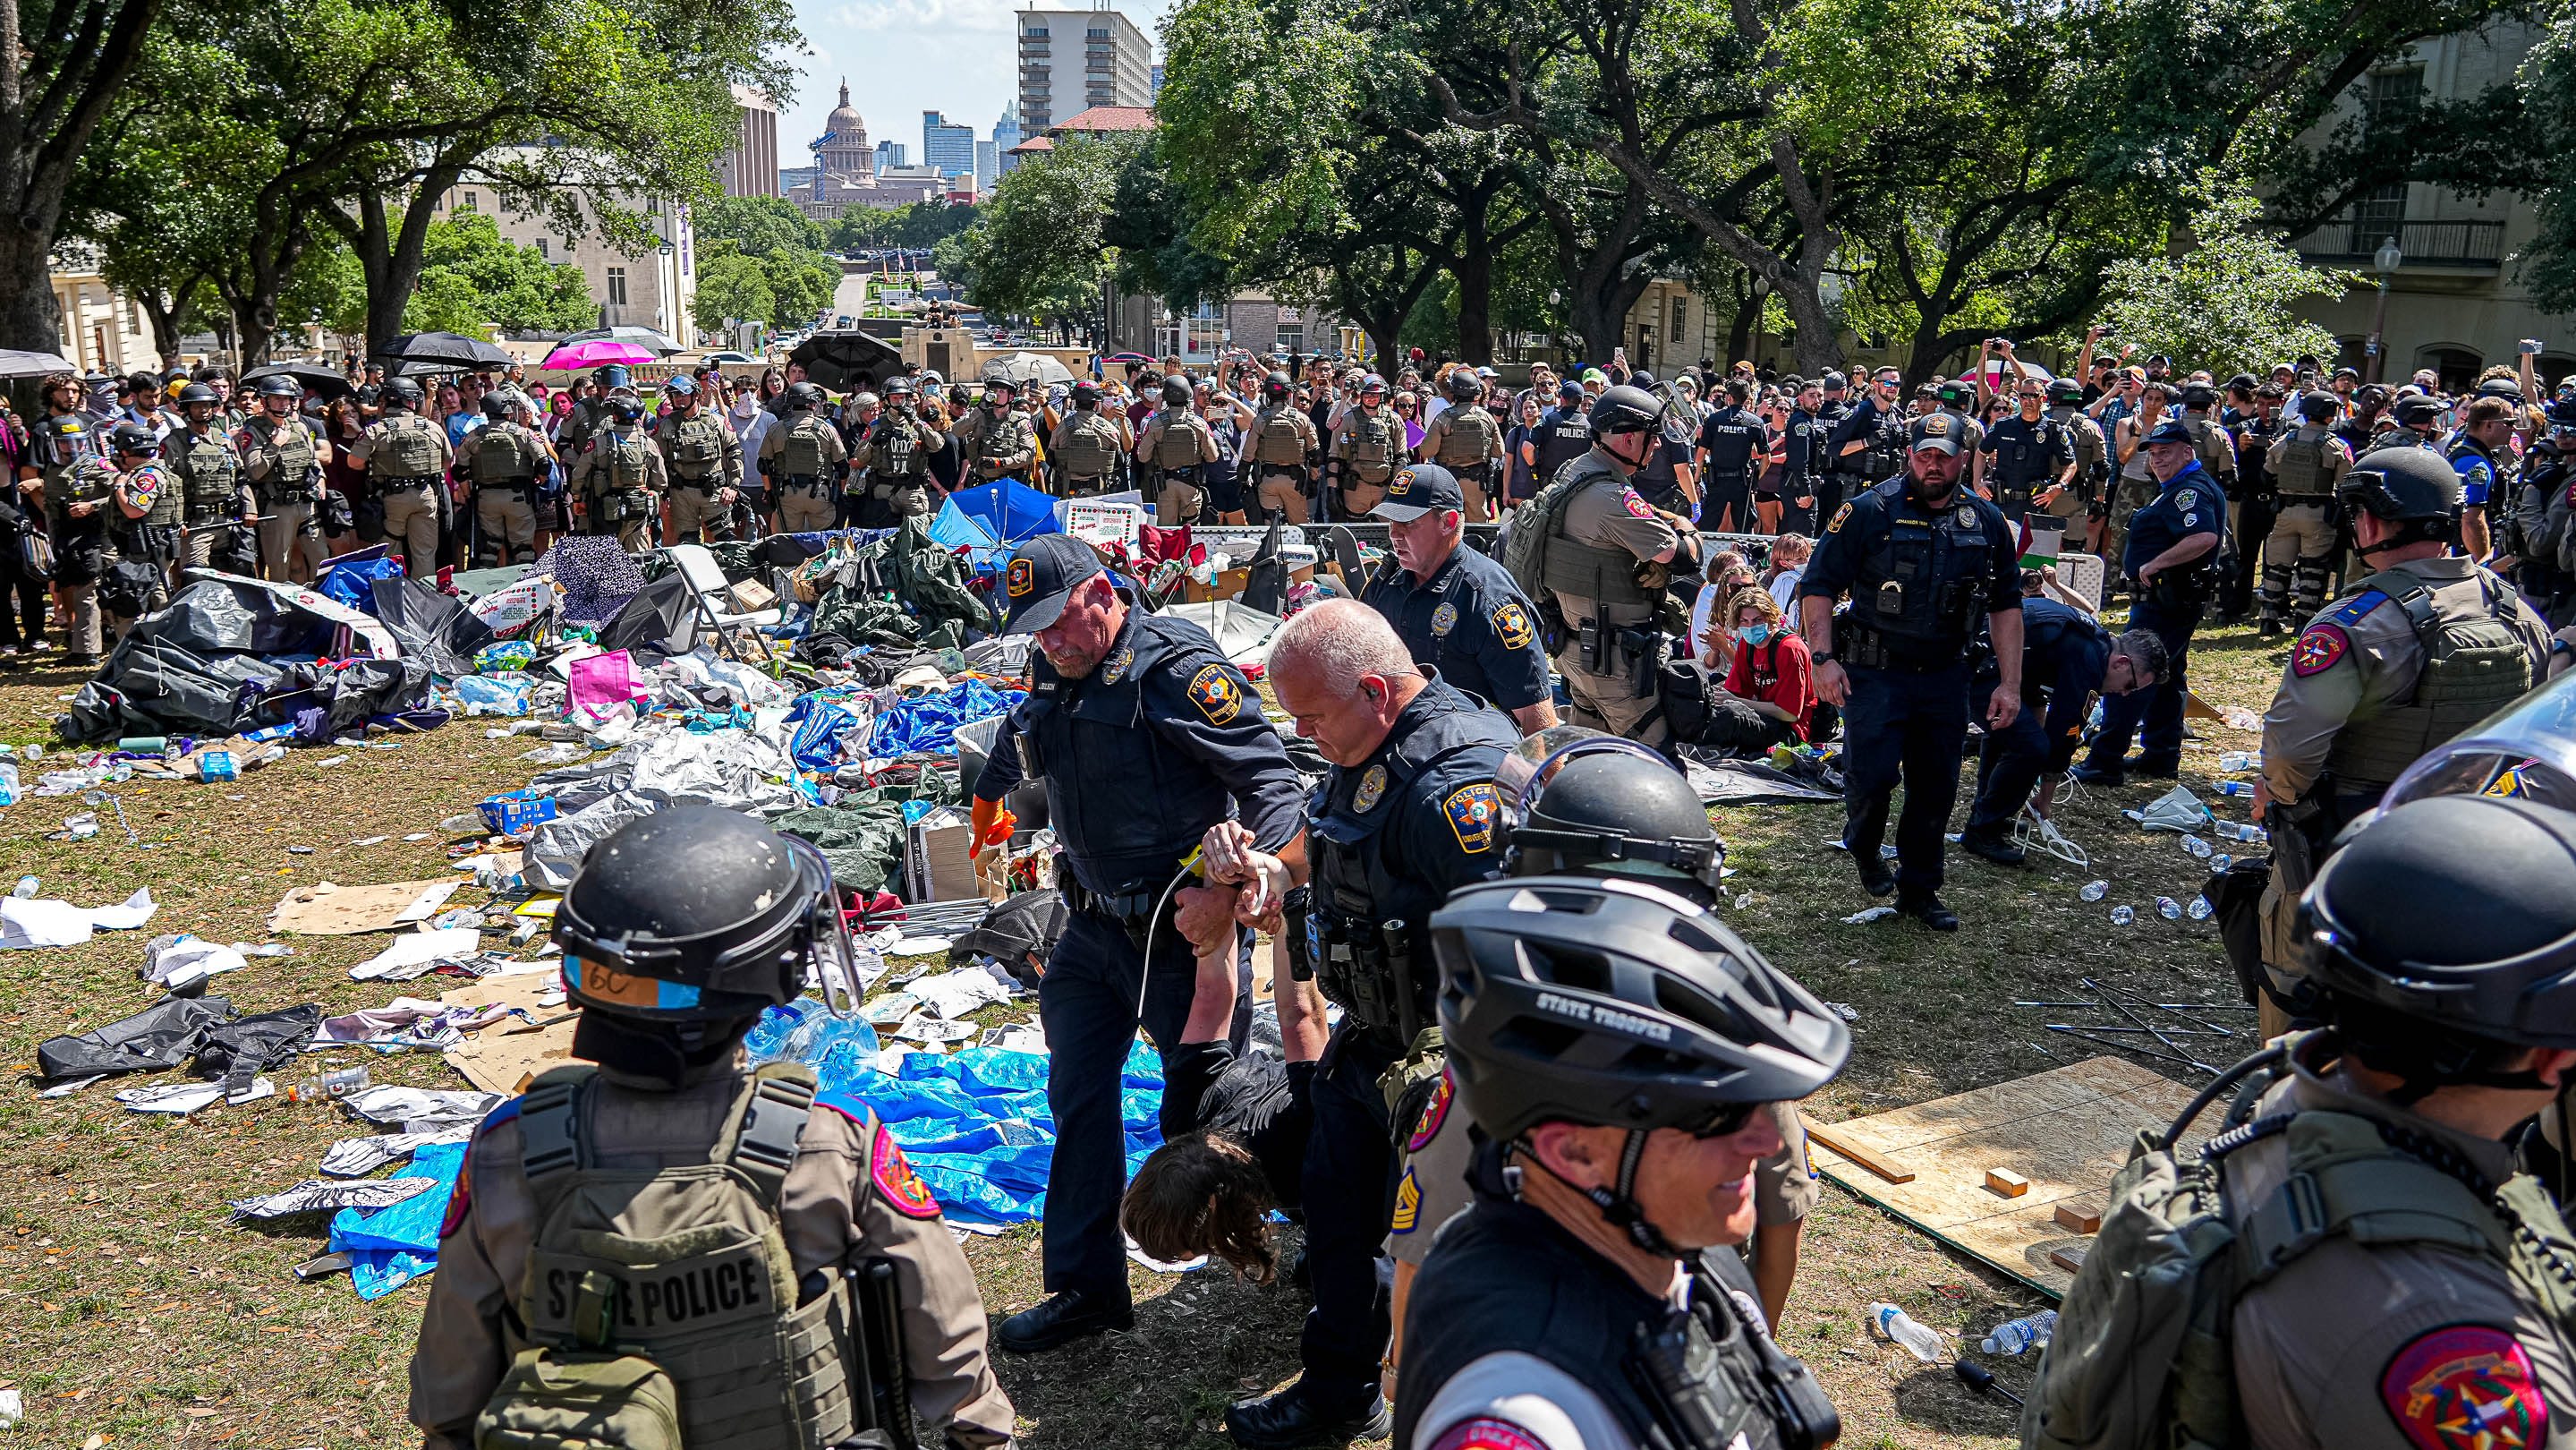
[554,806,853,1025]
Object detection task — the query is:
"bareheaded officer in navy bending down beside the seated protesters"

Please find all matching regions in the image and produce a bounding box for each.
[1958,598,2166,866]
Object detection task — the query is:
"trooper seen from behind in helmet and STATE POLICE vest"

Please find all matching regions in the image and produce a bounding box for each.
[410,806,1012,1450]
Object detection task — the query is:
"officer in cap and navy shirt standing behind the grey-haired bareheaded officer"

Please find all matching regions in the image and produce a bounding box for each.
[1360,464,1556,734]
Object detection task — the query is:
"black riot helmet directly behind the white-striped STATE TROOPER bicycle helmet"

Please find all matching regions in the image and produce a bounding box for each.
[1494,726,1726,904]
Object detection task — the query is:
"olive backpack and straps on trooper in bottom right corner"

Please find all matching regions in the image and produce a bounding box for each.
[2022,1036,2576,1450]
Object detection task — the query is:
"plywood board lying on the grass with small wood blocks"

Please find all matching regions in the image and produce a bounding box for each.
[1808,1056,2200,1295]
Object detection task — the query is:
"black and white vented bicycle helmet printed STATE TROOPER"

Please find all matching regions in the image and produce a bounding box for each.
[1430,875,1852,1154]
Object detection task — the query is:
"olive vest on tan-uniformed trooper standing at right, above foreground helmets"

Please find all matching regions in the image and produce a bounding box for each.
[2326,569,2532,793]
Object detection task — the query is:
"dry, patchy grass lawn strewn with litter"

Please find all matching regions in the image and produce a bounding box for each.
[0,615,2283,1450]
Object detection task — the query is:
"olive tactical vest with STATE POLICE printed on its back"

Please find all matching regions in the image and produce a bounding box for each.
[474,1063,868,1450]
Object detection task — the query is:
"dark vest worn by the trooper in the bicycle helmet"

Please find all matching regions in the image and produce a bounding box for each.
[1394,1164,1841,1450]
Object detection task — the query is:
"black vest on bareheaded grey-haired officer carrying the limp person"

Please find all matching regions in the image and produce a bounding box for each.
[1306,683,1520,1048]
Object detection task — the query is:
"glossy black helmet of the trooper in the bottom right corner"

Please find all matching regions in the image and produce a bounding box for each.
[2300,796,2576,1048]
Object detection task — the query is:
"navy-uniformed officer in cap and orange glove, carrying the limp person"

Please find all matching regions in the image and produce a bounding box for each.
[973,533,1308,1355]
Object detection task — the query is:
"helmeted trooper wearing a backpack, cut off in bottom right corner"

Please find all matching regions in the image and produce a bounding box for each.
[2022,796,2576,1450]
